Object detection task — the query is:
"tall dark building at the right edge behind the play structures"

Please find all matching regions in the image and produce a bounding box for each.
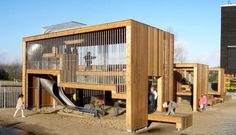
[220,4,236,74]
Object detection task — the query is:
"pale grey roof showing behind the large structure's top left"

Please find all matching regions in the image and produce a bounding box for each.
[43,21,86,33]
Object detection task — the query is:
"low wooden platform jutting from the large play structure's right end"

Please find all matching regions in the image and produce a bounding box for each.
[148,112,193,130]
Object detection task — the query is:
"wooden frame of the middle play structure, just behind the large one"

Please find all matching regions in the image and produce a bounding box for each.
[174,63,208,111]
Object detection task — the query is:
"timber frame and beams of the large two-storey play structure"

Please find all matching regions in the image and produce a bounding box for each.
[23,20,174,131]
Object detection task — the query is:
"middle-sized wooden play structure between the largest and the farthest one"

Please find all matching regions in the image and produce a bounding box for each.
[174,63,208,111]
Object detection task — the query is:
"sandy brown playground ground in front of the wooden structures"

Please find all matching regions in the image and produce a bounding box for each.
[0,99,236,135]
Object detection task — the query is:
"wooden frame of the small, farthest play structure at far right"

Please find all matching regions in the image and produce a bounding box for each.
[208,68,225,96]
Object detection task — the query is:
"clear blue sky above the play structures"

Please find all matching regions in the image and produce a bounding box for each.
[0,0,233,67]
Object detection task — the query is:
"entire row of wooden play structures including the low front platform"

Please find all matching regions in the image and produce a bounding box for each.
[23,20,230,132]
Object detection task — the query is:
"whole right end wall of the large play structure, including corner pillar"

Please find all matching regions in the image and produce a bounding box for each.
[126,21,174,130]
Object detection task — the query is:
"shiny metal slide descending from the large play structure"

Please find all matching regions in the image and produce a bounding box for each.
[40,78,76,108]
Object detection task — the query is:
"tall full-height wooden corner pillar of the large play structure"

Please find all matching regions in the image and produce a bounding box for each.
[126,21,148,131]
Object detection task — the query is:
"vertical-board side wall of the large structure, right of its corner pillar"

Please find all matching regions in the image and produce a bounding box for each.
[148,26,174,111]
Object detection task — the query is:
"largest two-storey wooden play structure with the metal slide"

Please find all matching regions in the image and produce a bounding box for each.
[23,20,177,131]
